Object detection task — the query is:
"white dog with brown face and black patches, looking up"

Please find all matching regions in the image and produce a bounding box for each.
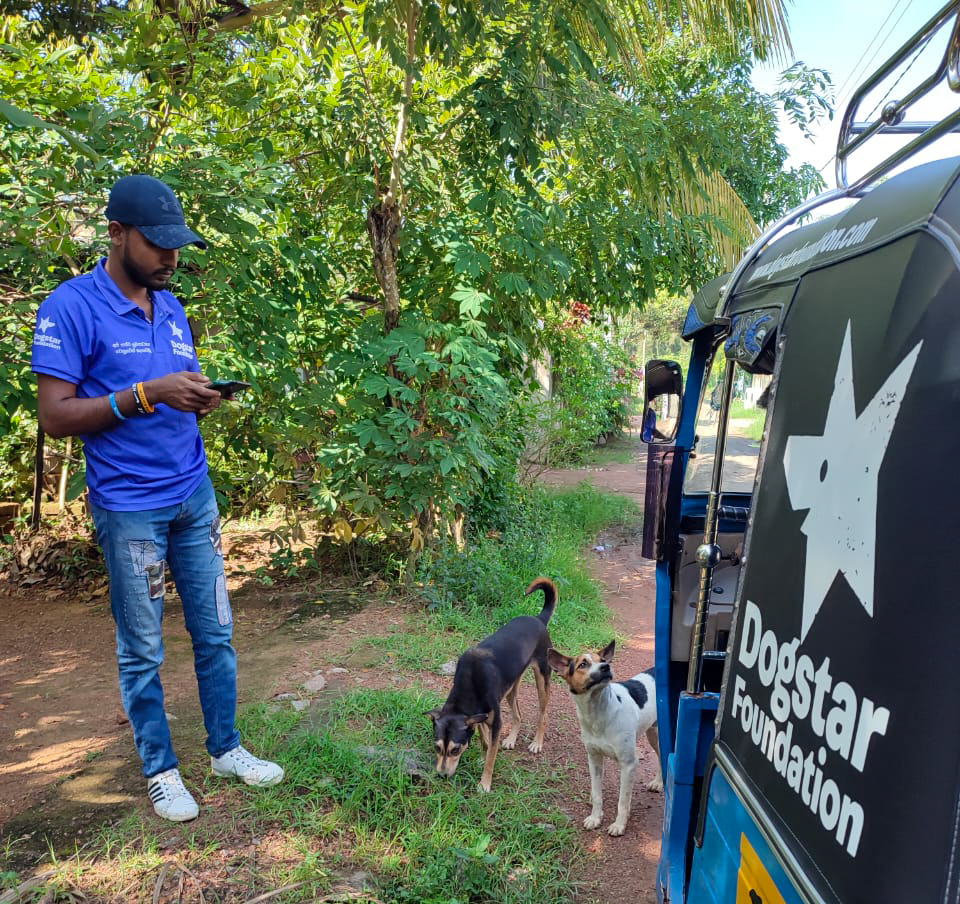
[547,641,663,835]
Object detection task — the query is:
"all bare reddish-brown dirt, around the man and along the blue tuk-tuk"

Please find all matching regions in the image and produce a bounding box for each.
[0,428,663,904]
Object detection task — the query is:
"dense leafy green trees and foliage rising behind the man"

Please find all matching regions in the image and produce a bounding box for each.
[0,0,824,564]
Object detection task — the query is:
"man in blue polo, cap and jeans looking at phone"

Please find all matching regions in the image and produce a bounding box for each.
[33,175,283,822]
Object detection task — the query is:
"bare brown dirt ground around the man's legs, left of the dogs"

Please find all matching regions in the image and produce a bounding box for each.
[0,556,405,865]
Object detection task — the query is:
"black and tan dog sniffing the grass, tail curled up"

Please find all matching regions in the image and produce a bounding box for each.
[427,578,557,791]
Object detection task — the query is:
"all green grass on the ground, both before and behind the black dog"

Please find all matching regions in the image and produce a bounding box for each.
[0,485,637,904]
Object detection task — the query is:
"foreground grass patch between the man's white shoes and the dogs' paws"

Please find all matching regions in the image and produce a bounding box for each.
[0,700,580,904]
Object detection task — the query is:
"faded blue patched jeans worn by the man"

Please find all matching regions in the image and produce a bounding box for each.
[92,477,240,778]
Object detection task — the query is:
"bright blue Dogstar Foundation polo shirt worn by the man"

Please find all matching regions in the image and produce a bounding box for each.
[32,259,207,512]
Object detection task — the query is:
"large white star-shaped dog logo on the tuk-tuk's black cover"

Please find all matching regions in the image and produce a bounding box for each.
[783,323,923,640]
